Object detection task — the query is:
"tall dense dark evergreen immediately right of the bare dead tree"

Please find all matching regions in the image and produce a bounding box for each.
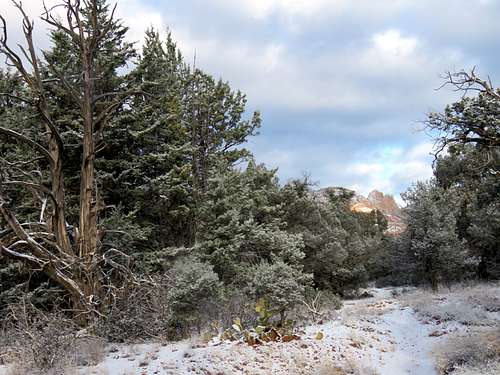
[99,30,192,251]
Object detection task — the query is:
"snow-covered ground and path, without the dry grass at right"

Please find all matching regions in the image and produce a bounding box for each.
[0,287,500,375]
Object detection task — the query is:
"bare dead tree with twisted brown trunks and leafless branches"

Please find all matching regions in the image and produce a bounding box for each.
[0,0,128,313]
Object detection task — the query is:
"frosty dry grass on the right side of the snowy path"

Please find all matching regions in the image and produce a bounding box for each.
[398,283,500,375]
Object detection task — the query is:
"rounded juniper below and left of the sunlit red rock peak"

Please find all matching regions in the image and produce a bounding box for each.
[280,178,386,294]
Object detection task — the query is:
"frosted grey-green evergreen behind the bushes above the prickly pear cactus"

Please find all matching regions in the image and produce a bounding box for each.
[198,161,304,284]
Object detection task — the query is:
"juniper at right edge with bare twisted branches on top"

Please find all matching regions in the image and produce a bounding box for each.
[427,69,500,278]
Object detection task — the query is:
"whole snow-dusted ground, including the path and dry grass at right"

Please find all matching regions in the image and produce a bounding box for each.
[0,284,500,375]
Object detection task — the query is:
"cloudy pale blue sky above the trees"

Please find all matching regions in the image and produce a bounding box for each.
[0,0,500,203]
